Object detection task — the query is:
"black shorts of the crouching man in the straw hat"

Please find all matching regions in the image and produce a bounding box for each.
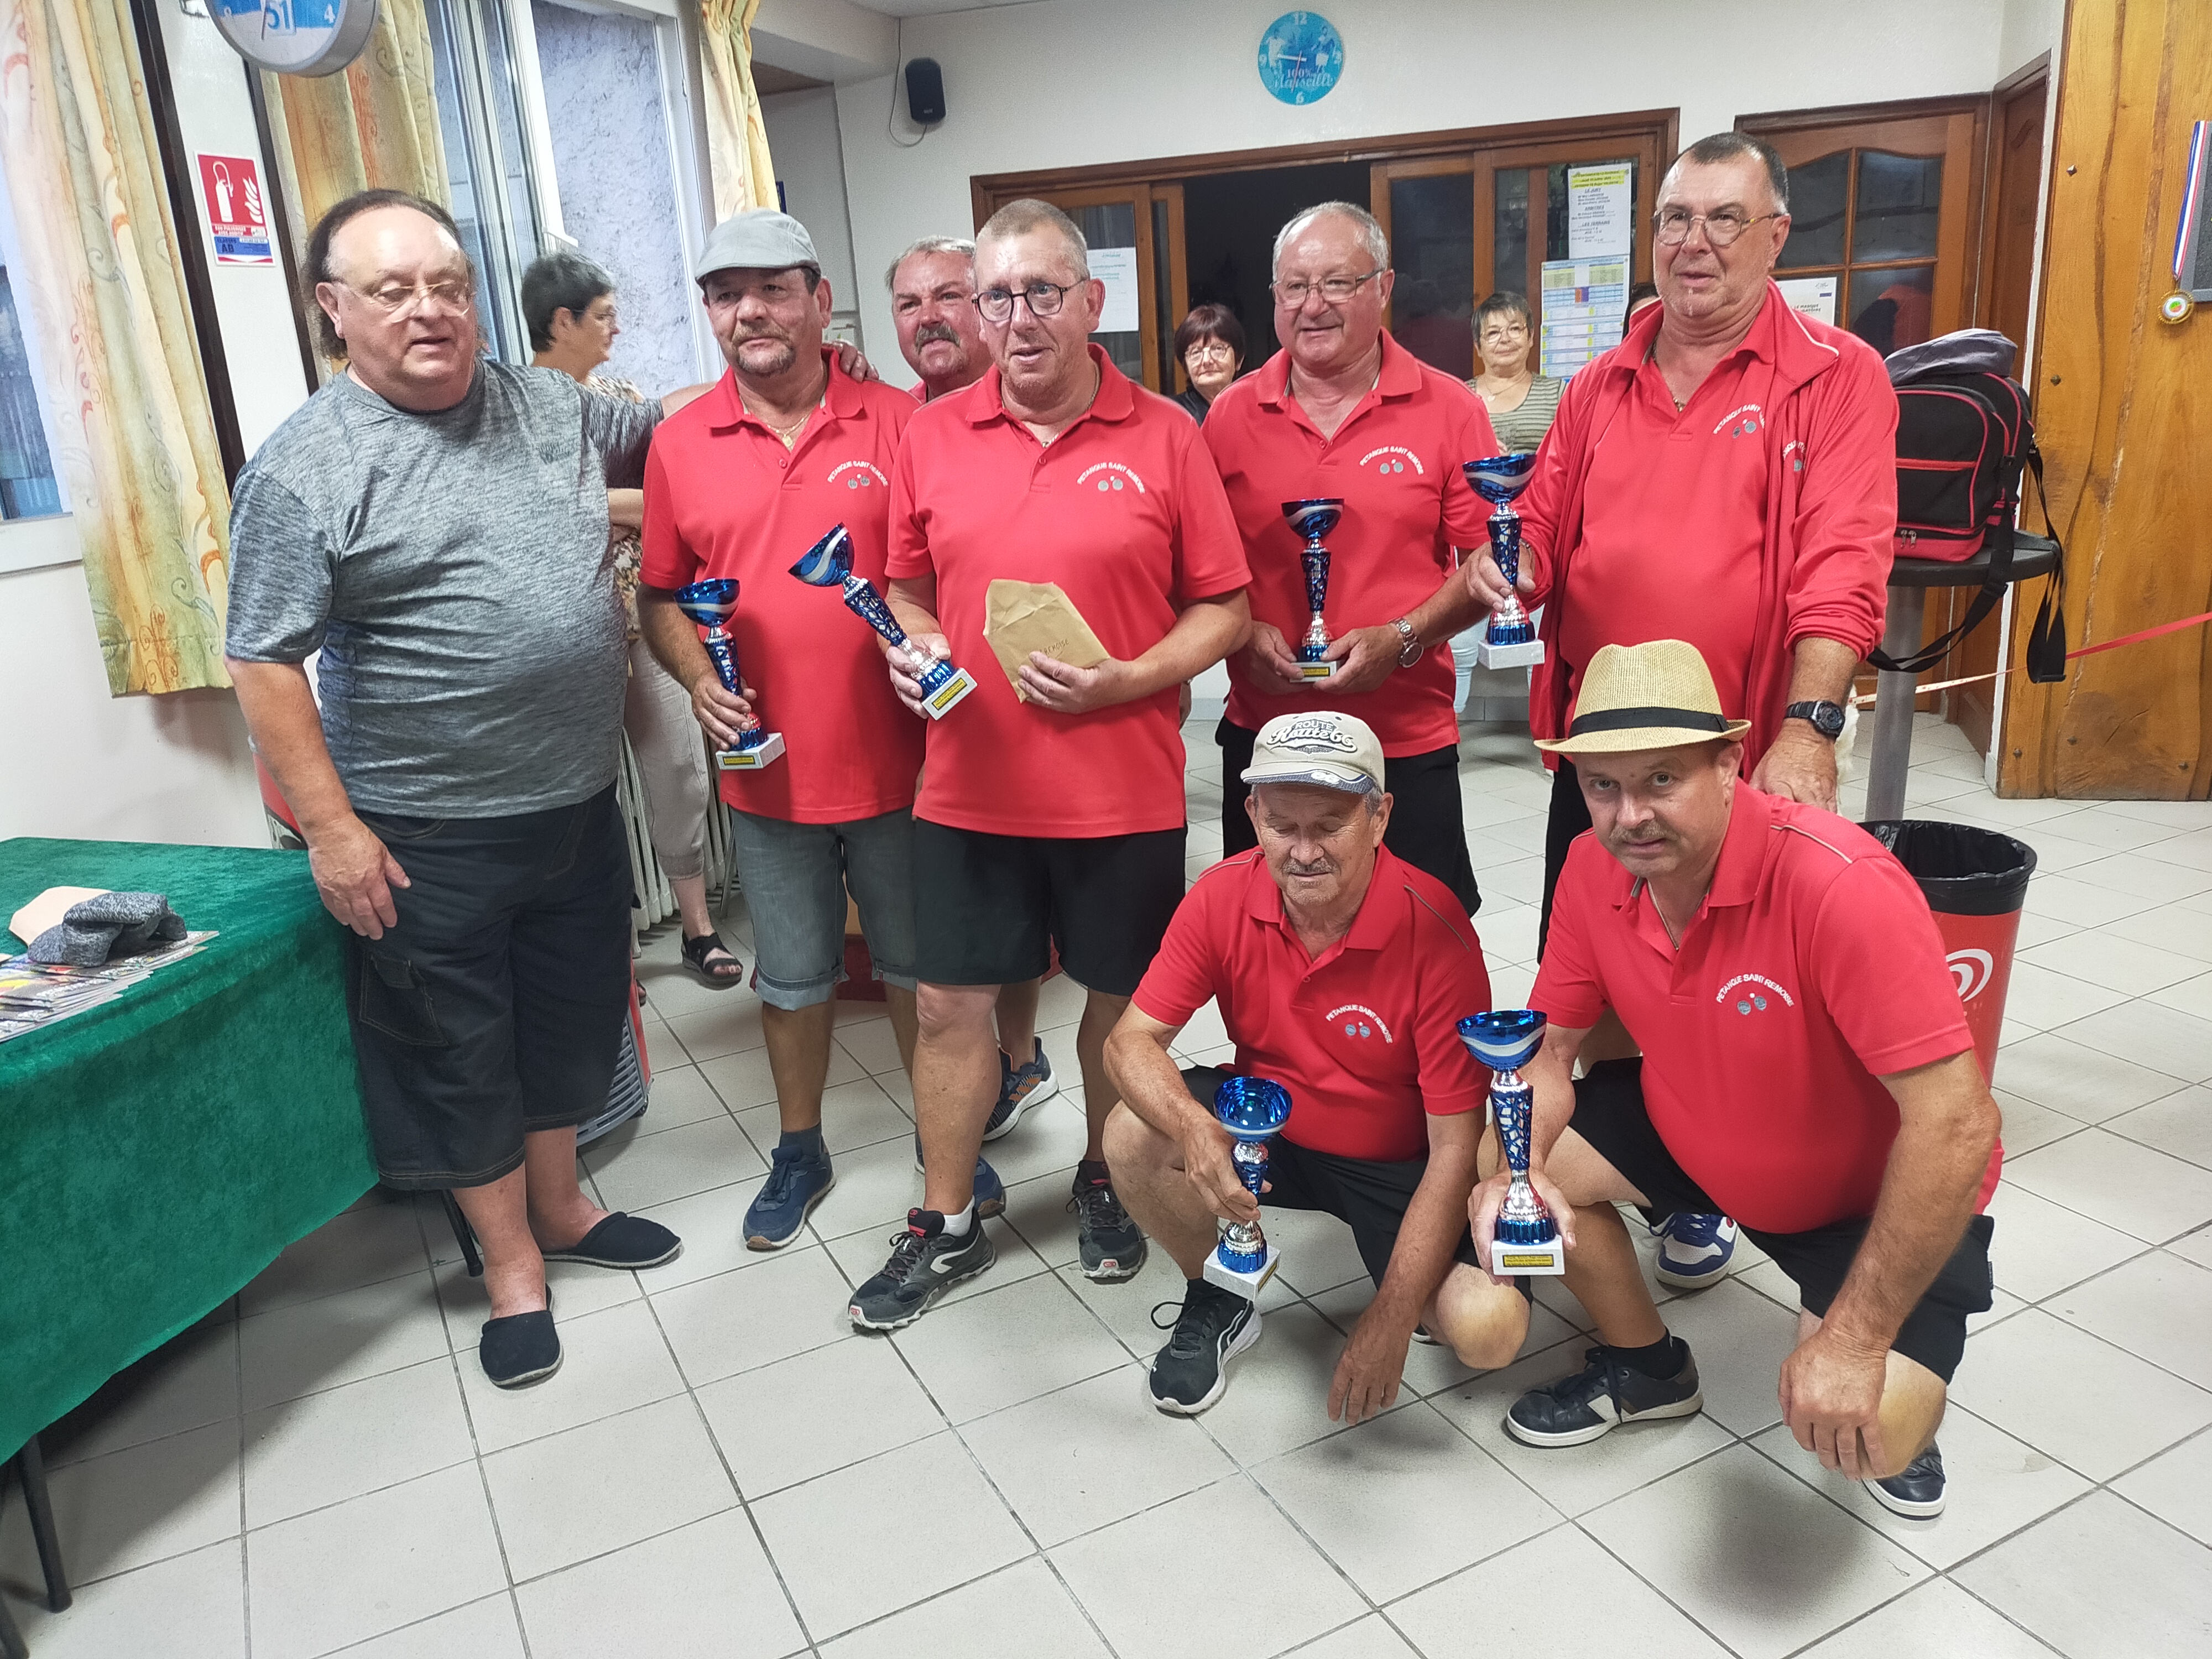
[1568,1060,1997,1383]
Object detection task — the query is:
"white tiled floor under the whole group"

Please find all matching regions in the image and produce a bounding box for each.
[0,721,2212,1659]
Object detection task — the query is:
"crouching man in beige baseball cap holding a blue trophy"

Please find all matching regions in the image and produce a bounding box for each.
[1106,710,1528,1422]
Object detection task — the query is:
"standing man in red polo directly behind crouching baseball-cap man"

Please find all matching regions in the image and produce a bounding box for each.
[1206,201,1498,916]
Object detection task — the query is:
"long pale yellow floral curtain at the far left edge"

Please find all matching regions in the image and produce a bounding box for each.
[0,0,230,697]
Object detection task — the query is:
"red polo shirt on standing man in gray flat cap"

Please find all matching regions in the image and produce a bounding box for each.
[641,352,922,823]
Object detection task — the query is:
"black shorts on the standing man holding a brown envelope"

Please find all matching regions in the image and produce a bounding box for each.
[914,818,1183,998]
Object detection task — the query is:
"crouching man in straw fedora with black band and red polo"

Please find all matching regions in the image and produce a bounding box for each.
[1473,639,2004,1515]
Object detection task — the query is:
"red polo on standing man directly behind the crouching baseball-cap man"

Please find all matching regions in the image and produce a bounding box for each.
[1203,334,1498,757]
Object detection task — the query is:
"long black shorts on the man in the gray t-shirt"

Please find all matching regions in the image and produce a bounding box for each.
[345,787,630,1190]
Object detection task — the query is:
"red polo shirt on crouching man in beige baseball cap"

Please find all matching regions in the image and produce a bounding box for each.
[1137,847,1491,1164]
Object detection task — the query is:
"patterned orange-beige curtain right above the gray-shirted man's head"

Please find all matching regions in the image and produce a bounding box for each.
[260,0,453,376]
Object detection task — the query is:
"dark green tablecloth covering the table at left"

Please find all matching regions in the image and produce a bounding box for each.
[0,838,376,1458]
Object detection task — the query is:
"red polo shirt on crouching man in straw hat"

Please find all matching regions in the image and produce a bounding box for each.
[1531,783,2004,1232]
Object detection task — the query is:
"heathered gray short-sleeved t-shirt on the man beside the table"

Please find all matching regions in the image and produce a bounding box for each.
[228,369,659,818]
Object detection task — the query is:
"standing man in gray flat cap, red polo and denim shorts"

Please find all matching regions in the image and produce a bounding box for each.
[639,208,922,1250]
